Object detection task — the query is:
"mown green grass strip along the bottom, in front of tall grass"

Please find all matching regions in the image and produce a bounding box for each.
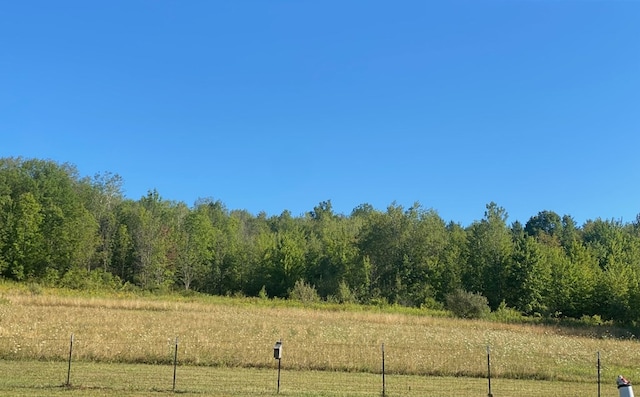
[0,361,618,397]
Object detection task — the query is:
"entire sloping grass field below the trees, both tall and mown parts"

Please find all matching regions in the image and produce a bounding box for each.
[0,285,640,396]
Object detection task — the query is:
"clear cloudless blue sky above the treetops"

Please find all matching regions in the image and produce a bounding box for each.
[0,0,640,225]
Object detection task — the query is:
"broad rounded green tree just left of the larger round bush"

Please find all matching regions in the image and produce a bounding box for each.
[358,203,450,306]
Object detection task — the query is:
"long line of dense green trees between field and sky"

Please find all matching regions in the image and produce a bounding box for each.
[0,158,640,324]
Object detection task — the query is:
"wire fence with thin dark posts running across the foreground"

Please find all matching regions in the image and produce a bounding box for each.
[0,334,640,397]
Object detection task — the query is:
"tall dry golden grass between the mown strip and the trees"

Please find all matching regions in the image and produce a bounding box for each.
[0,289,640,382]
